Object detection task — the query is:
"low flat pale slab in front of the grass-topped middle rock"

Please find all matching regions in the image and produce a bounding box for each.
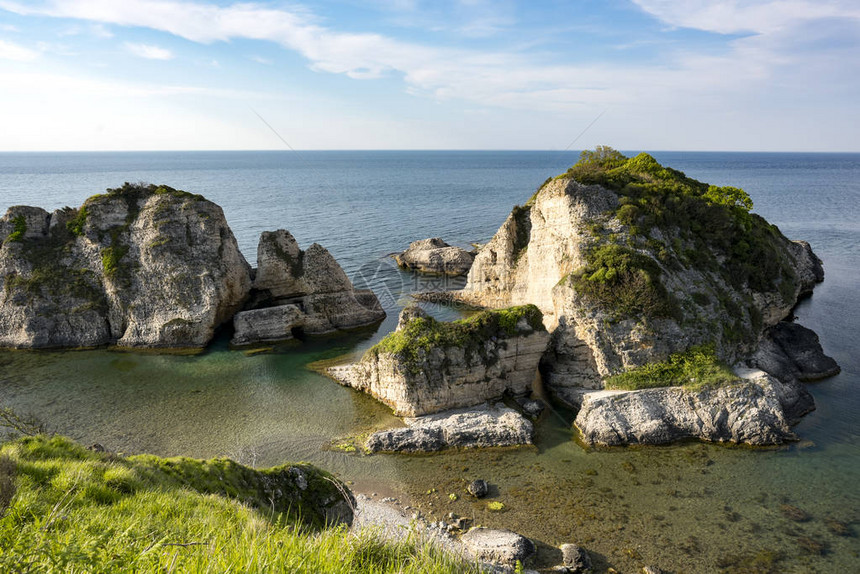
[365,403,534,453]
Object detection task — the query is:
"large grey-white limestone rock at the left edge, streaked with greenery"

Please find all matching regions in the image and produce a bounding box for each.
[0,184,251,348]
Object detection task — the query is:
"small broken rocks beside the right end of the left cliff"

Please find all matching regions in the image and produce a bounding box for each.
[232,229,385,345]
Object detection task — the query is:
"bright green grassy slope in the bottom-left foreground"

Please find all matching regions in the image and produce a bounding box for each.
[0,436,477,574]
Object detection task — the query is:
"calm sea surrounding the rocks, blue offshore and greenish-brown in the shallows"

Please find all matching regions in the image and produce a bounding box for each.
[0,151,860,573]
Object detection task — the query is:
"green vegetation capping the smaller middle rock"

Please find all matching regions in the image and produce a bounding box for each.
[365,305,546,374]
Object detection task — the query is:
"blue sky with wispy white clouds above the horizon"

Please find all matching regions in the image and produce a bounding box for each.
[0,0,860,151]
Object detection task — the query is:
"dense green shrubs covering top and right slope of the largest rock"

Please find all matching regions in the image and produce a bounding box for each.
[559,146,797,316]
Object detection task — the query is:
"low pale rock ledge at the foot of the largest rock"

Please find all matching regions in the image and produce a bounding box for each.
[575,371,796,446]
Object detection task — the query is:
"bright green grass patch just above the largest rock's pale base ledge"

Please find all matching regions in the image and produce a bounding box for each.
[604,345,738,391]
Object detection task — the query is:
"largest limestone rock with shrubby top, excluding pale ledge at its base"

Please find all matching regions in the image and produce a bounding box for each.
[453,154,824,414]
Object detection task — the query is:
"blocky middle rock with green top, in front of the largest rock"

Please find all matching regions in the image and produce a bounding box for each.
[328,305,549,417]
